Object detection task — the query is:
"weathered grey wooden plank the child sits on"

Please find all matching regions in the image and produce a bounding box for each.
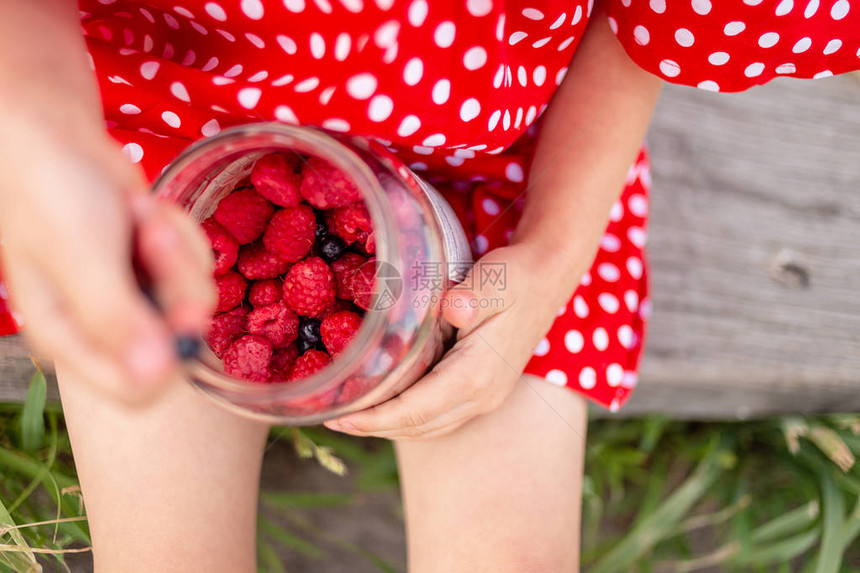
[0,76,860,419]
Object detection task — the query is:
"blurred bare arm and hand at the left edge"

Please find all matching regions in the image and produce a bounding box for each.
[0,0,214,399]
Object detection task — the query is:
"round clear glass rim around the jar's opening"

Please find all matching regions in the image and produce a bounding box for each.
[152,122,399,402]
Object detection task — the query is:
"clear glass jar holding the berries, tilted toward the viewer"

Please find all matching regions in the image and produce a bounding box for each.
[154,123,472,425]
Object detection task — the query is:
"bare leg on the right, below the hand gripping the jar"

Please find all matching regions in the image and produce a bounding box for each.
[396,376,587,573]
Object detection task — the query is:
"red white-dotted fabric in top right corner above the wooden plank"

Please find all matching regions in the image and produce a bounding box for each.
[607,0,860,92]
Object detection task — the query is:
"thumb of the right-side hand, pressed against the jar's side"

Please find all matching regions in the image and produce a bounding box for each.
[442,247,515,335]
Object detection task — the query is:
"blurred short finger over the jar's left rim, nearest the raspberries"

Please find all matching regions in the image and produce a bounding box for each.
[137,204,217,335]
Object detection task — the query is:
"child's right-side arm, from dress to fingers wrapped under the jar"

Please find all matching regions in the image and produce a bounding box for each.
[327,5,660,438]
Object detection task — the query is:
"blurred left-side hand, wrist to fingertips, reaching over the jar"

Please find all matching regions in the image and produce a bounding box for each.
[0,107,216,402]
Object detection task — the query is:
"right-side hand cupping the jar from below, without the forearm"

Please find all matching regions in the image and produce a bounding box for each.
[326,243,570,439]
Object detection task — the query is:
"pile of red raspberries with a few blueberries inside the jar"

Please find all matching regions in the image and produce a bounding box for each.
[202,153,375,383]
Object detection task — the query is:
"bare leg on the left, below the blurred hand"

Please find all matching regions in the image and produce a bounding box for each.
[60,371,268,573]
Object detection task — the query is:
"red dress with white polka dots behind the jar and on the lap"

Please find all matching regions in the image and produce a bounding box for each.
[0,0,649,409]
